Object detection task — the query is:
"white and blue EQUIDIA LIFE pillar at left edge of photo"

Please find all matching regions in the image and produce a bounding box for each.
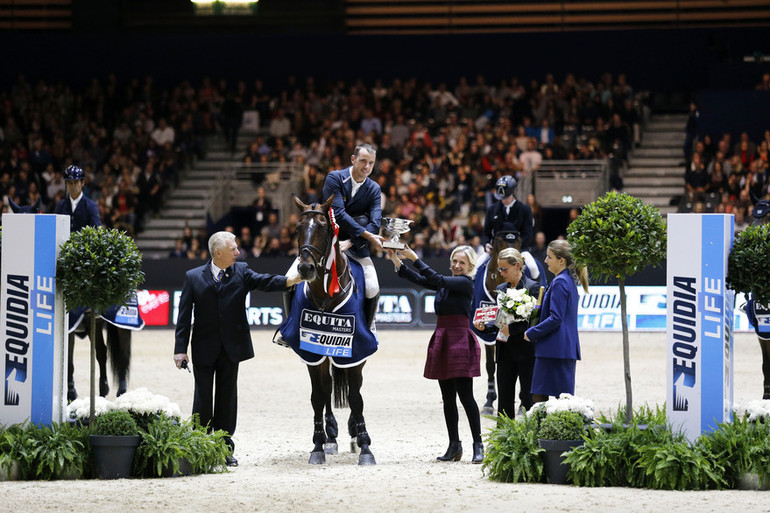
[0,214,70,425]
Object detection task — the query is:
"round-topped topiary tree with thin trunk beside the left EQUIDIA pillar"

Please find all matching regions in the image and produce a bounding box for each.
[56,226,144,422]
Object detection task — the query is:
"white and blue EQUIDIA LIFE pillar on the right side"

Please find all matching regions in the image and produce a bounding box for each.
[666,214,735,440]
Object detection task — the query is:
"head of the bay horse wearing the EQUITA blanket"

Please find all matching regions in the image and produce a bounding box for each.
[294,195,334,281]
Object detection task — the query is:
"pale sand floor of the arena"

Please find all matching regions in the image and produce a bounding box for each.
[0,329,770,513]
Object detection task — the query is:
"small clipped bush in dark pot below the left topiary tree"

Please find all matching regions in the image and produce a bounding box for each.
[89,410,142,479]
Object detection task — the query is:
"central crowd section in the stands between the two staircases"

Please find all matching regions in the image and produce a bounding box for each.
[177,70,641,257]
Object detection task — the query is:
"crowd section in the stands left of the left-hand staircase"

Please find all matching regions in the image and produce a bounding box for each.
[0,75,207,234]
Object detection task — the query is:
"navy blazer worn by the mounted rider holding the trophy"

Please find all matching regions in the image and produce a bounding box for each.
[321,166,382,258]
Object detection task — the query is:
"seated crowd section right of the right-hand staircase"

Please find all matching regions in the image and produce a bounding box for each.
[679,97,770,231]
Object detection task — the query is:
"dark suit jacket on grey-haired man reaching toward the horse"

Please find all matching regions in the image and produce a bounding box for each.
[174,260,286,366]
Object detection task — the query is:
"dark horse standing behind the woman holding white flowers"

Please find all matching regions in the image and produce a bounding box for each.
[471,228,547,415]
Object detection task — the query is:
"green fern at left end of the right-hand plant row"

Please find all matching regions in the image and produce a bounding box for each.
[482,415,543,483]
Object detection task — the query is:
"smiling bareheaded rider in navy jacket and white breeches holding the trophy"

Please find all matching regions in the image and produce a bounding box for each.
[276,144,383,330]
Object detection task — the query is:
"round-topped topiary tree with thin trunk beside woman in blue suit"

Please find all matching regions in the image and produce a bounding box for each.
[567,191,666,424]
